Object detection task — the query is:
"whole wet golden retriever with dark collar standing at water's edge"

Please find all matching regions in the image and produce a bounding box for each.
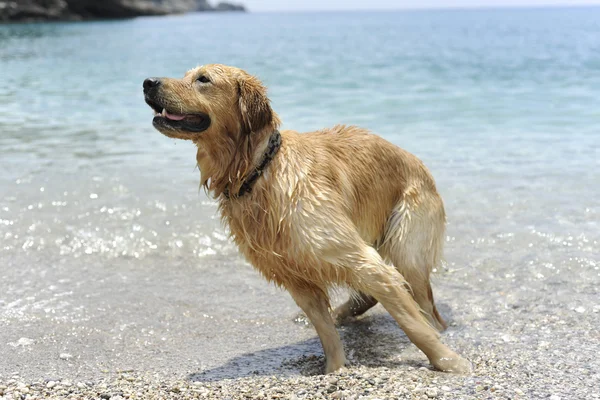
[143,65,471,373]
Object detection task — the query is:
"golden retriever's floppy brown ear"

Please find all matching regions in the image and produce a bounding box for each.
[238,75,273,134]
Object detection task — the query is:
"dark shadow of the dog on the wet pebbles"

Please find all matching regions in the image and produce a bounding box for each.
[188,307,449,382]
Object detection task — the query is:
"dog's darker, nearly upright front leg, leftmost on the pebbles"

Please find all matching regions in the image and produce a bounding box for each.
[286,284,346,374]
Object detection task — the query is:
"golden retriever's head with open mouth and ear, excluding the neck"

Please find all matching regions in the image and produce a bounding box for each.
[143,64,277,141]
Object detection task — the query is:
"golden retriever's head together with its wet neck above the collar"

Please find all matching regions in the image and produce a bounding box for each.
[144,64,280,195]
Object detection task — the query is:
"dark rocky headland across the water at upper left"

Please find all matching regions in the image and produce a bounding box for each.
[0,0,245,22]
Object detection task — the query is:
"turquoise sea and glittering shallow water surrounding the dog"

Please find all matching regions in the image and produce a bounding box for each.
[0,8,600,377]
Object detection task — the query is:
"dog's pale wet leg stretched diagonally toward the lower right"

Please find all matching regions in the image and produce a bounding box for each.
[338,244,471,373]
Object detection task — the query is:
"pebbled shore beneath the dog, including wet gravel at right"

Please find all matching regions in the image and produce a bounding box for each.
[0,282,600,400]
